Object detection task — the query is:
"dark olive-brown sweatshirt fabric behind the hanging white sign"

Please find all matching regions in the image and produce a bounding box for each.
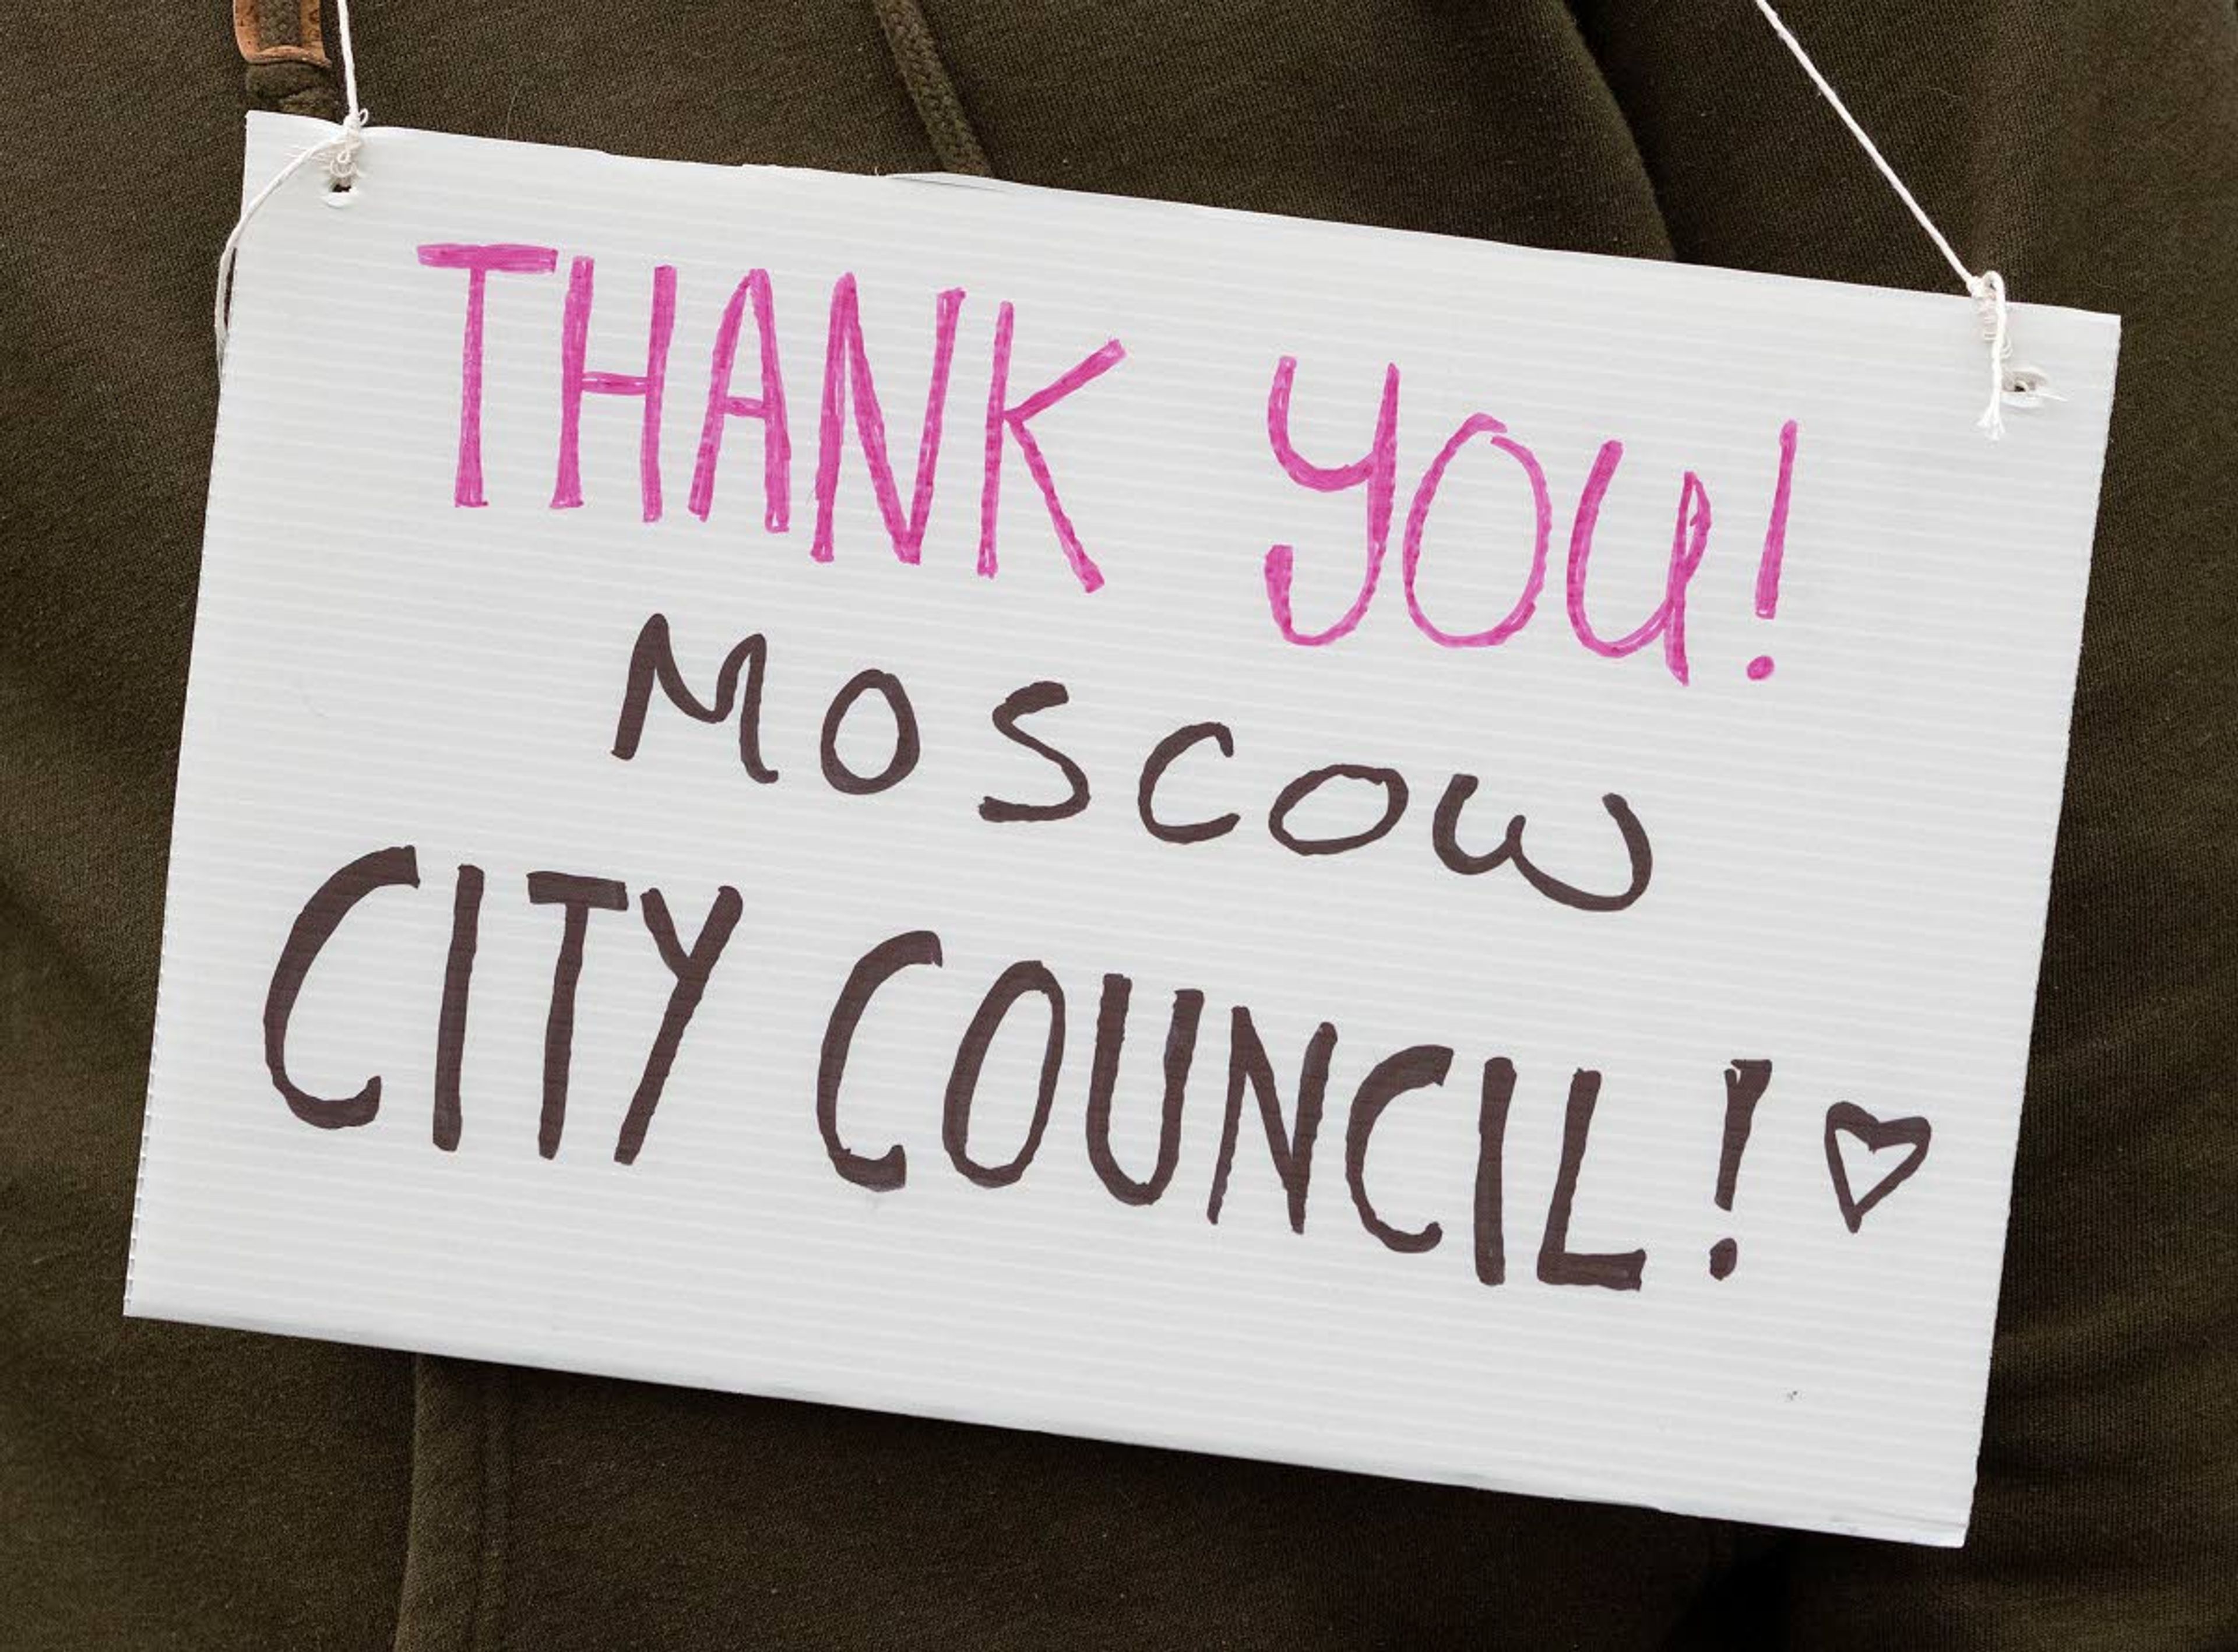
[0,0,2238,1652]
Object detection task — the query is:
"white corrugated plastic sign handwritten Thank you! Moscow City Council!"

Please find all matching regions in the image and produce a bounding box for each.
[128,117,2117,1545]
